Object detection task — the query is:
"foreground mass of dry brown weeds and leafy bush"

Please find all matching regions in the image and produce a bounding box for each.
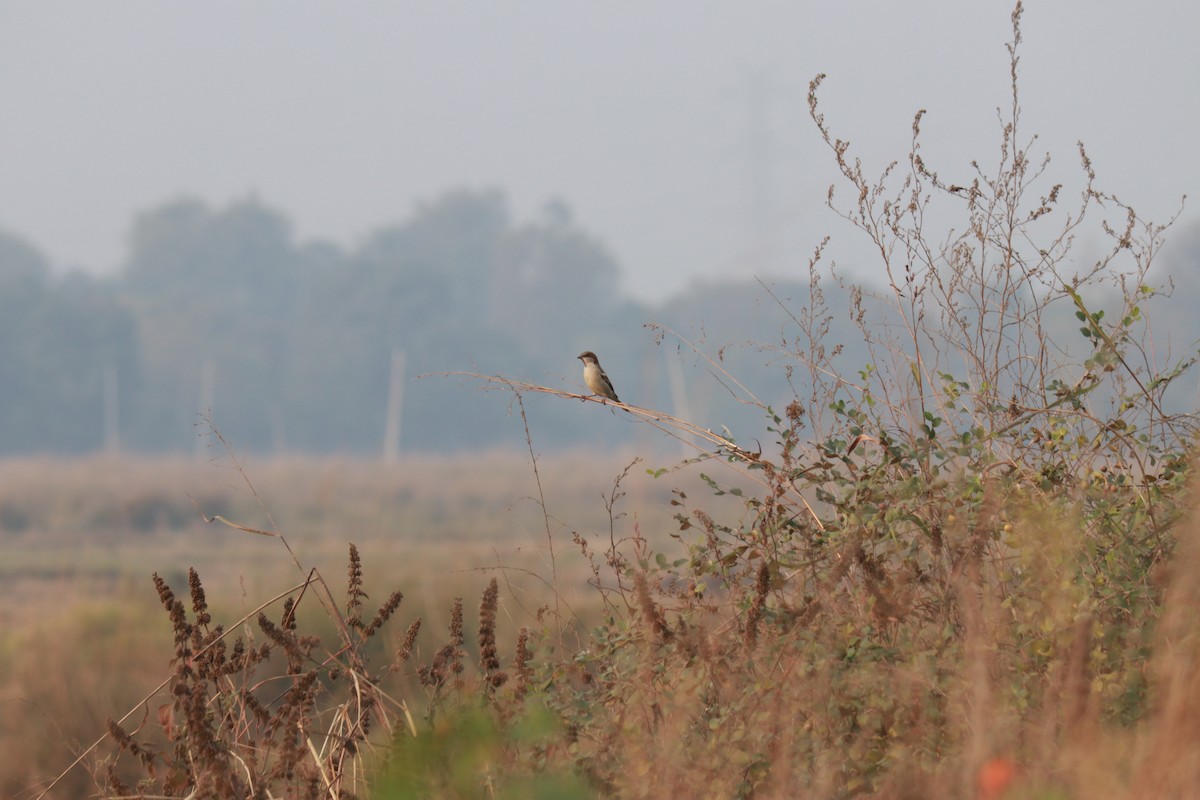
[9,5,1200,800]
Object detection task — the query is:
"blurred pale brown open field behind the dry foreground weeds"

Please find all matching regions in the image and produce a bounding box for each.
[0,453,739,798]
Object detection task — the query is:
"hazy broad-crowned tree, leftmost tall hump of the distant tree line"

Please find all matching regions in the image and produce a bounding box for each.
[125,199,318,450]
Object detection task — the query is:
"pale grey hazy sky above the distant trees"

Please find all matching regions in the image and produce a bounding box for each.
[0,0,1200,299]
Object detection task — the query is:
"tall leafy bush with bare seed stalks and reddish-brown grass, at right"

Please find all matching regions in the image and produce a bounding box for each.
[530,4,1195,796]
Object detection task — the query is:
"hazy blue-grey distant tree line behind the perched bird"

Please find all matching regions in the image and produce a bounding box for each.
[0,191,1200,455]
